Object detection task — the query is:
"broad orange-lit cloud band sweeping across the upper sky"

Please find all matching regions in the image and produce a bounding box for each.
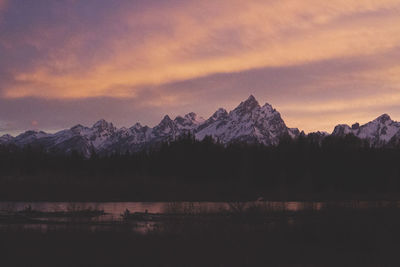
[0,0,400,101]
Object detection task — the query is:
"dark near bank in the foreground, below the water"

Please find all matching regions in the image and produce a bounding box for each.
[0,206,400,267]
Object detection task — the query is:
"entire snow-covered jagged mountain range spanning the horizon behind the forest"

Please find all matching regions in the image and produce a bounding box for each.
[0,95,400,157]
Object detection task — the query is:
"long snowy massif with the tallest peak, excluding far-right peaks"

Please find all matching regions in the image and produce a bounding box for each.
[0,98,310,156]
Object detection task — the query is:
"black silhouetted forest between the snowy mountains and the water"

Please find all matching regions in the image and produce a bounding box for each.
[0,134,400,200]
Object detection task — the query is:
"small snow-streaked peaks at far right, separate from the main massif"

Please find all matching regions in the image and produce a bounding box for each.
[332,114,400,146]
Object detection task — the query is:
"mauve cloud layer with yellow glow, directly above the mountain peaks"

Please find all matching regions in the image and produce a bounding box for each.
[0,49,400,135]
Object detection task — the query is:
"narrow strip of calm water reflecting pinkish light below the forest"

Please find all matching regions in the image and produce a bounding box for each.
[0,201,400,232]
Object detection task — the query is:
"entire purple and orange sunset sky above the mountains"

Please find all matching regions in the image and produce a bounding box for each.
[0,0,400,135]
